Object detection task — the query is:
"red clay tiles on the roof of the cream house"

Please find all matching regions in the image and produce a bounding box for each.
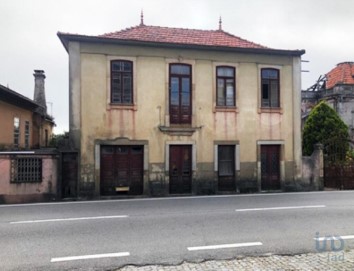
[99,25,269,49]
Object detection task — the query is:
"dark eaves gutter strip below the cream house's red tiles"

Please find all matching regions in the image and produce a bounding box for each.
[57,32,305,57]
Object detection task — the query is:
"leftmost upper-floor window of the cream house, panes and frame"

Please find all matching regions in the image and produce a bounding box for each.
[111,60,133,105]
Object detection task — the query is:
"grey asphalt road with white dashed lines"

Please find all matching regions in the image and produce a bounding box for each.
[0,191,354,271]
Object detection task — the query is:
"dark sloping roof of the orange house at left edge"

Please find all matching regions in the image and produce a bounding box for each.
[0,85,39,111]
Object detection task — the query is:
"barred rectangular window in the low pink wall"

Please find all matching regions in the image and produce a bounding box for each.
[11,158,42,183]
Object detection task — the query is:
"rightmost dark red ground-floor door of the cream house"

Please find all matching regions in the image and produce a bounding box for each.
[261,145,280,190]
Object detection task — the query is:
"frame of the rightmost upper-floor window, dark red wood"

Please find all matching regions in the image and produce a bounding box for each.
[260,67,281,109]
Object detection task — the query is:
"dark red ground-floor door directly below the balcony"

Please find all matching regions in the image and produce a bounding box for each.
[170,145,192,194]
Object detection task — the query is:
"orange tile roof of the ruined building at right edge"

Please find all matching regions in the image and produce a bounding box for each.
[326,62,354,89]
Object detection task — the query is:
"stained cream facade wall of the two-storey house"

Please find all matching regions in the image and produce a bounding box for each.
[59,34,304,196]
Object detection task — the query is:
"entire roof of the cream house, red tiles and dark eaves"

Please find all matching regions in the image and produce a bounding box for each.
[58,24,305,56]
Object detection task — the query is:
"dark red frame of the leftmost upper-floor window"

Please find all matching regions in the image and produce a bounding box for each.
[109,59,134,106]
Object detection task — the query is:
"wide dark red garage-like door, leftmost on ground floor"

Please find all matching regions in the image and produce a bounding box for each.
[101,146,144,195]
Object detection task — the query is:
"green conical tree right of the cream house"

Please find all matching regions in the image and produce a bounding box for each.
[302,101,349,160]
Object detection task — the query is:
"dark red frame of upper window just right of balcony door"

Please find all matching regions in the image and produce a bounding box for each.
[215,65,236,108]
